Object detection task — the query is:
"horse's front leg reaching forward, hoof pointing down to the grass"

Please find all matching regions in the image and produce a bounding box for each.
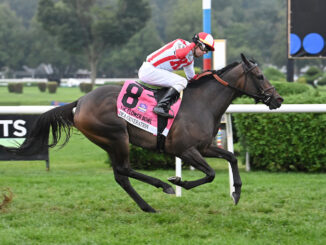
[202,145,242,204]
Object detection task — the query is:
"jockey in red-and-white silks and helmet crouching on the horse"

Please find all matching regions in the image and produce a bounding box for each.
[138,32,214,118]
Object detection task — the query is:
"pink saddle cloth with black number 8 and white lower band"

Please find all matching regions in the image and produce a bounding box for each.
[117,80,181,136]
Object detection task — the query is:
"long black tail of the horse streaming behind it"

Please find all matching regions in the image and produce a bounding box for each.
[1,100,78,155]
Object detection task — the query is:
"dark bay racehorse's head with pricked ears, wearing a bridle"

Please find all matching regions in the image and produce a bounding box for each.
[239,54,283,110]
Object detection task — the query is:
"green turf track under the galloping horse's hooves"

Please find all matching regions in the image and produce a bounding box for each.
[0,135,326,245]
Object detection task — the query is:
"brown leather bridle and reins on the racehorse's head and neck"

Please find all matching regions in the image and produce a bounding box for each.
[196,63,275,105]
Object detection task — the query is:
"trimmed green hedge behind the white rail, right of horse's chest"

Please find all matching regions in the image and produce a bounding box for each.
[233,83,326,172]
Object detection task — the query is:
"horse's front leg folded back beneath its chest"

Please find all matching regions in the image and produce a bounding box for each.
[169,147,215,190]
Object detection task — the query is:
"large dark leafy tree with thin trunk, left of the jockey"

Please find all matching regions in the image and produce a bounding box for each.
[37,0,149,84]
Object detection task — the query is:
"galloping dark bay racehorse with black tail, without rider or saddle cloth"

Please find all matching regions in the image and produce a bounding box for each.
[2,54,283,212]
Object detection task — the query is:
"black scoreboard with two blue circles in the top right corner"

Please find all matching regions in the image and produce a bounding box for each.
[288,0,326,58]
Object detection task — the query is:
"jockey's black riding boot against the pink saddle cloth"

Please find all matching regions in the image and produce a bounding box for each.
[153,87,180,118]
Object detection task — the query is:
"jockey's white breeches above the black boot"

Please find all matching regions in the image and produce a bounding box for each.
[138,62,188,93]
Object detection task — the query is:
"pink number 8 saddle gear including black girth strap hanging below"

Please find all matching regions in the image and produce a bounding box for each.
[117,80,182,152]
